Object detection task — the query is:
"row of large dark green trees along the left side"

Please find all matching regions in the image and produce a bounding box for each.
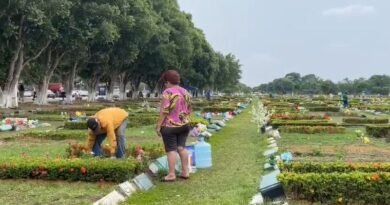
[0,0,241,107]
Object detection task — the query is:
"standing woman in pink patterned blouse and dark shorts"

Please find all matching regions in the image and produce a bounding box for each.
[156,70,191,182]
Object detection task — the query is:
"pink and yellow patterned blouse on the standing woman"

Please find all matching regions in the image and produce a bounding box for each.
[160,86,191,127]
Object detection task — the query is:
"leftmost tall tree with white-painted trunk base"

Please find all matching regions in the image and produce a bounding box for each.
[0,0,55,108]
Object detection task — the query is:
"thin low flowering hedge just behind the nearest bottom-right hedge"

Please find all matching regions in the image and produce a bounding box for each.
[278,162,390,173]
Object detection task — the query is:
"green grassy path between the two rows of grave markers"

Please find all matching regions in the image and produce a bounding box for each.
[125,109,265,205]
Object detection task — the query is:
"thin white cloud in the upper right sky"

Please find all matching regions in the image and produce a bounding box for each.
[322,4,376,16]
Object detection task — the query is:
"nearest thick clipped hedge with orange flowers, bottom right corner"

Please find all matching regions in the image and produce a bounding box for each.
[278,172,390,204]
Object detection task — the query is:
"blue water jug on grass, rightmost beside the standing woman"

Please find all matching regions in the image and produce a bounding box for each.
[194,136,212,169]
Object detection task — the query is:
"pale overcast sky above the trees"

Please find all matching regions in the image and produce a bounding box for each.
[178,0,390,86]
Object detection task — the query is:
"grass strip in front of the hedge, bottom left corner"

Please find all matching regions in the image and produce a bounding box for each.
[0,180,115,205]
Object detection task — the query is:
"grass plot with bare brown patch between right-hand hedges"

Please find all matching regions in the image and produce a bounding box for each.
[278,127,390,162]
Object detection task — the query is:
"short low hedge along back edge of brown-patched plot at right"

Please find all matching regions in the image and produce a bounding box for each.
[280,126,345,134]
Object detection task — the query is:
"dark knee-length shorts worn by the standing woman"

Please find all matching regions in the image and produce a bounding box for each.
[161,125,190,152]
